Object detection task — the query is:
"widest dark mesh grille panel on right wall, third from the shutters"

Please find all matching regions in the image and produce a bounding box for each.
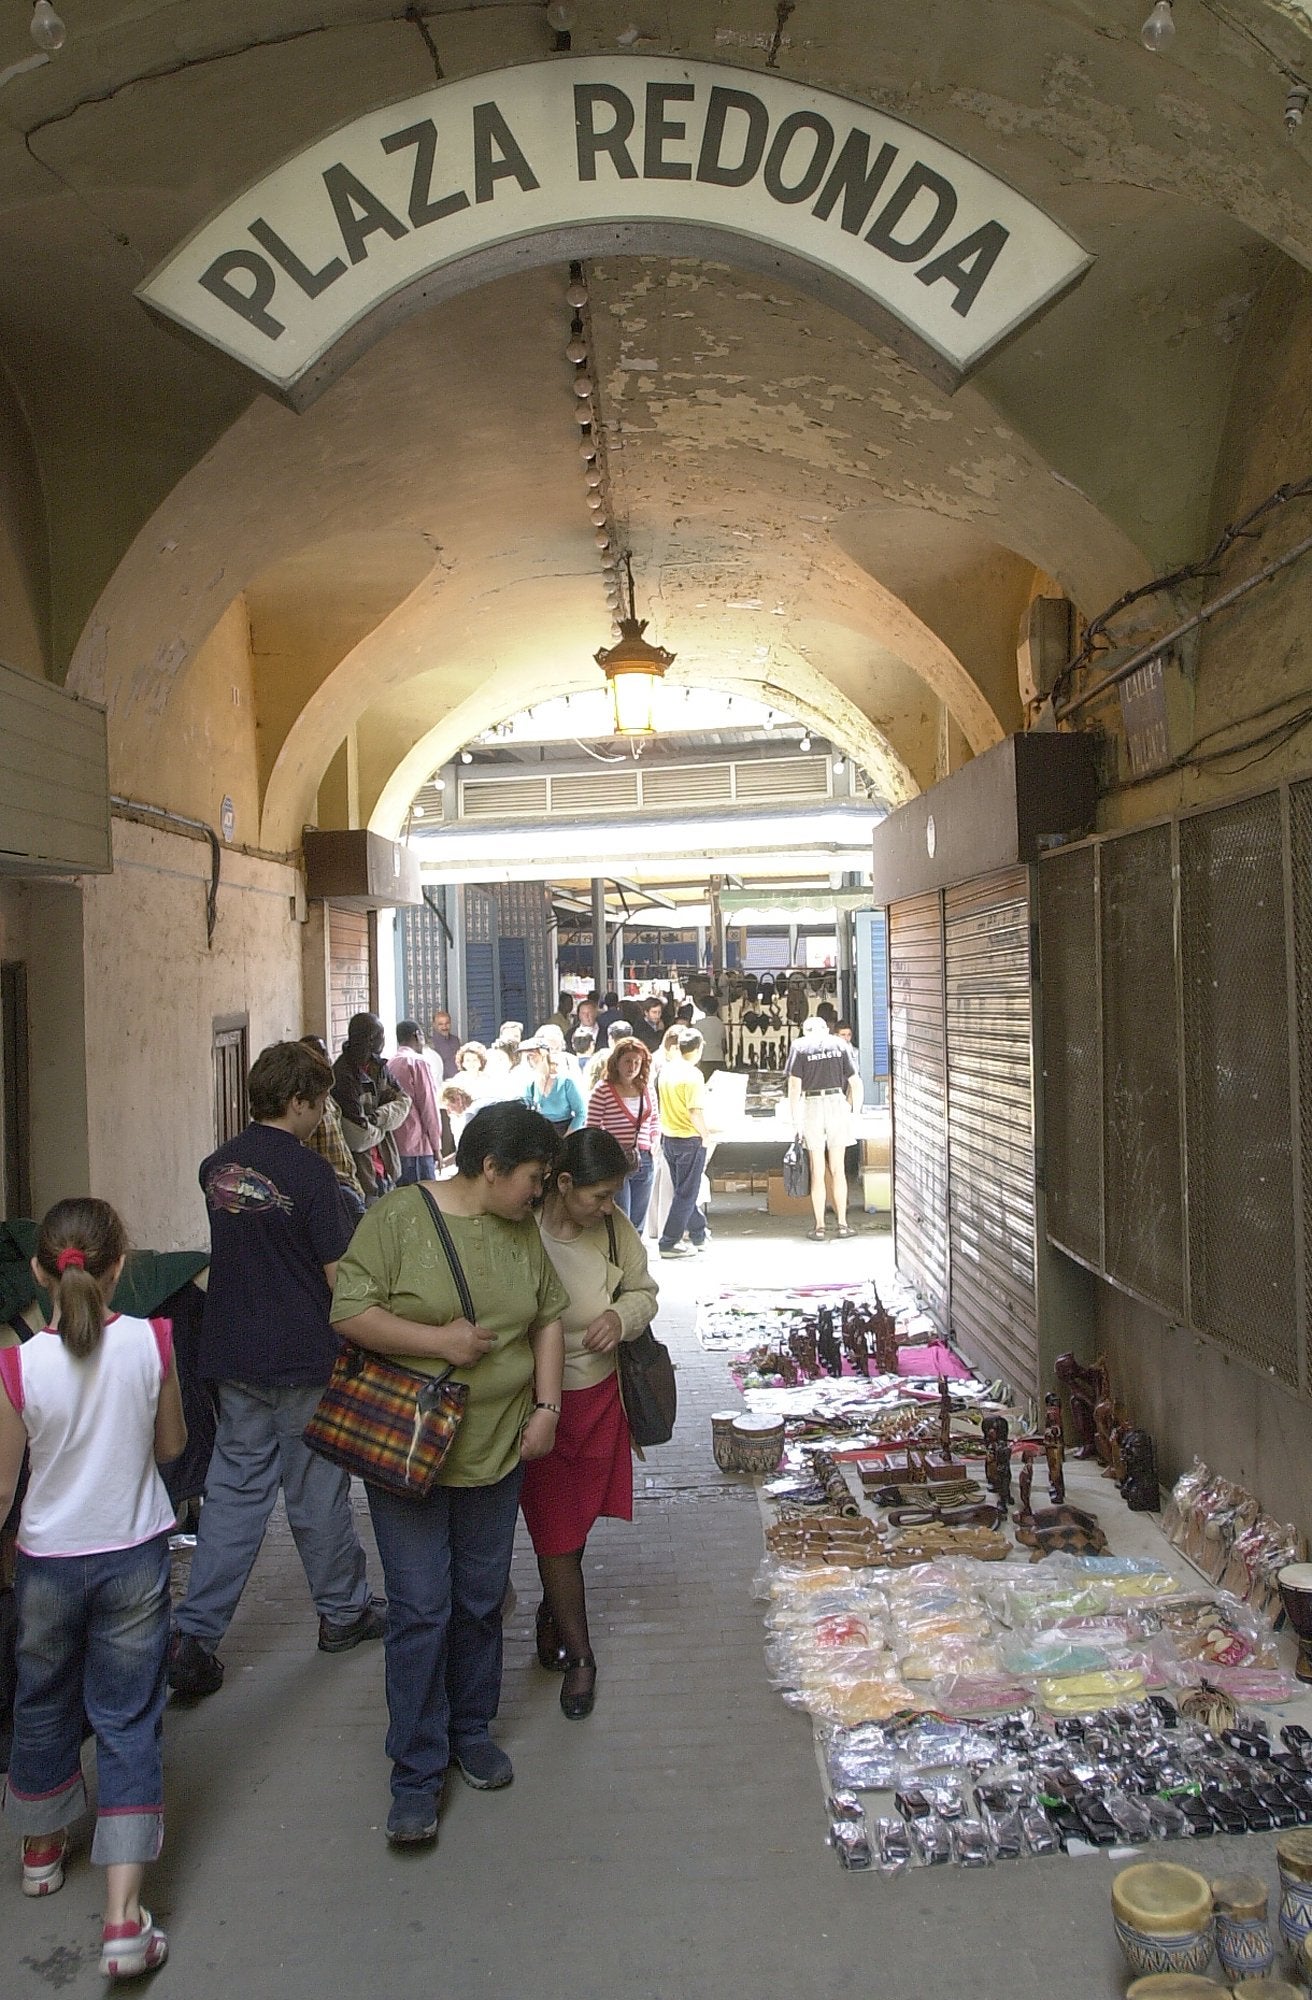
[1180,792,1298,1386]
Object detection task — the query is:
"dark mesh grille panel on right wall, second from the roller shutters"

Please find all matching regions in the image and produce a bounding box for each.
[1102,826,1184,1314]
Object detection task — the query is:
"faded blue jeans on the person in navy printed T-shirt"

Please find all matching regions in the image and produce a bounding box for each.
[176,1382,370,1652]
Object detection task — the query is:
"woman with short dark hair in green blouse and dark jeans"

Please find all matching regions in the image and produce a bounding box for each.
[332,1102,568,1846]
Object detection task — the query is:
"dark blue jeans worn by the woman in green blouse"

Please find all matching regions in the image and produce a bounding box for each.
[364,1466,524,1806]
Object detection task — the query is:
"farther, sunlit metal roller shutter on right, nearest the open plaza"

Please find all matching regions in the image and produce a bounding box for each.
[888,892,948,1330]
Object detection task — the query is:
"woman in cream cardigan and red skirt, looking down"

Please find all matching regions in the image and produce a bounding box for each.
[520,1126,656,1722]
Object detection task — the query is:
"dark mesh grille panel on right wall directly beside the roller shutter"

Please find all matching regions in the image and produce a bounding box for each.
[1038,848,1102,1264]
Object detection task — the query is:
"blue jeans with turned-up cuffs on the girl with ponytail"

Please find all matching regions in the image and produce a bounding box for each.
[4,1534,168,1866]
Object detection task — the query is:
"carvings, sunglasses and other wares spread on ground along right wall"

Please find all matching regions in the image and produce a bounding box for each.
[698,1284,1312,1872]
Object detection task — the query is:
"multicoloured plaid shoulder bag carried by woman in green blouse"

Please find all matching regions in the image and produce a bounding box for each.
[304,1188,476,1500]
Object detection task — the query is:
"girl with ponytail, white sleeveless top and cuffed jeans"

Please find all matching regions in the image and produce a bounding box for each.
[0,1196,186,1978]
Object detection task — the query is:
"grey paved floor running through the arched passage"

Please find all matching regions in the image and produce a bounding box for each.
[0,1214,1304,2000]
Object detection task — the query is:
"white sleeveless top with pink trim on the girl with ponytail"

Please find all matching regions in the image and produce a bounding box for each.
[0,1314,174,1556]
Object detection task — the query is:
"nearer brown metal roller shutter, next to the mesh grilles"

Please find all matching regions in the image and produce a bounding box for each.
[944,868,1038,1396]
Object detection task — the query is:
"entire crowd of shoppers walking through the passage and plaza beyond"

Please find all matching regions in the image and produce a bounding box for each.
[0,994,858,1978]
